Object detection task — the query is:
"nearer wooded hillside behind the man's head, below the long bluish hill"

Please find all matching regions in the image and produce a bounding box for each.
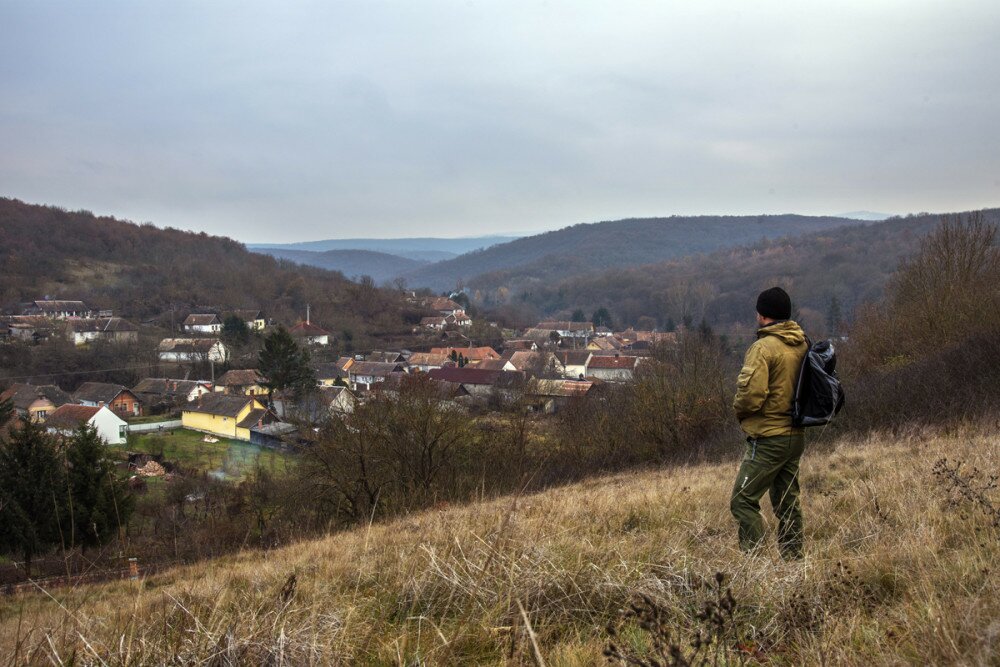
[469,209,1000,330]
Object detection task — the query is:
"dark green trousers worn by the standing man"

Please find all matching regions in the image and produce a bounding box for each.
[729,434,805,559]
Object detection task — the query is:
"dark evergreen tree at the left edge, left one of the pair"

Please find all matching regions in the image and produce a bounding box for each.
[0,419,67,576]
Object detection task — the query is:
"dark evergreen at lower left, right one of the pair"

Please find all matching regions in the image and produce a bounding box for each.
[66,426,133,549]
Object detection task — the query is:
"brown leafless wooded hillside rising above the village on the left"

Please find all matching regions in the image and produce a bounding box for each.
[0,198,405,334]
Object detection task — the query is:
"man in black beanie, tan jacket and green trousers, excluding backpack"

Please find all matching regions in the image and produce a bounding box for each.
[729,287,808,559]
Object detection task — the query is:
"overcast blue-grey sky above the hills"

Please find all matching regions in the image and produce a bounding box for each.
[0,0,1000,242]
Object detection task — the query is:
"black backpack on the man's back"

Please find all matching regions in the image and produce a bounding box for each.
[792,338,844,426]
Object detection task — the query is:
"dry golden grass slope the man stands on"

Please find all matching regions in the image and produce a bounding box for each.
[0,424,1000,665]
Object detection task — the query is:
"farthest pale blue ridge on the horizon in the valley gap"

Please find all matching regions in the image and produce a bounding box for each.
[247,235,519,262]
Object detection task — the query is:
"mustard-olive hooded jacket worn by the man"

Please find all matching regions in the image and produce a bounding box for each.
[733,320,807,438]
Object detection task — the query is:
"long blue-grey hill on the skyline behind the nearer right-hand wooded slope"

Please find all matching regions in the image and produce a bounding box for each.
[404,215,859,290]
